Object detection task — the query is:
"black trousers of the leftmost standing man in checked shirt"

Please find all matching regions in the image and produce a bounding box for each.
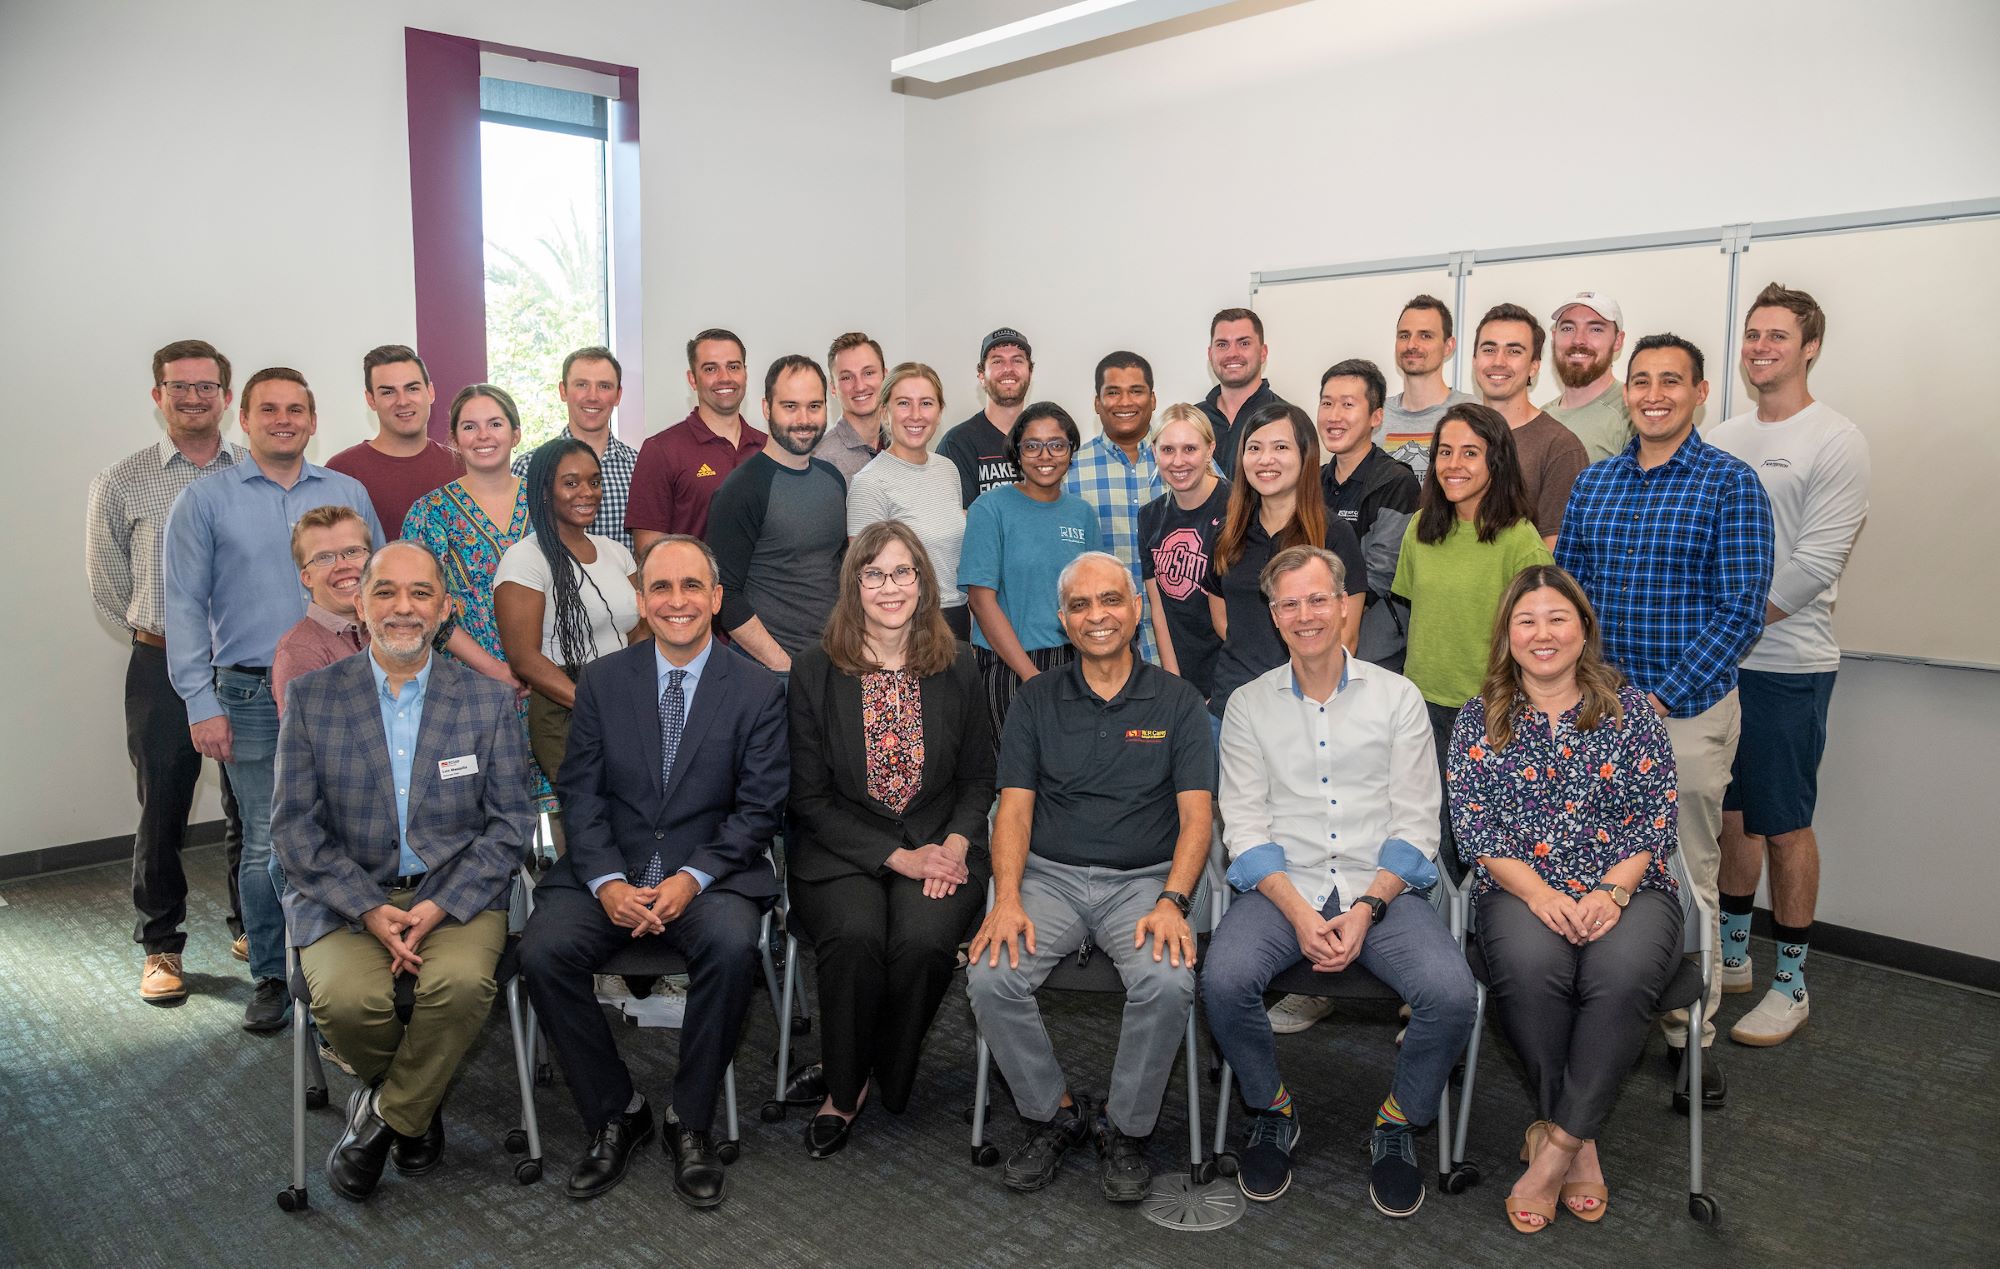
[126,639,244,955]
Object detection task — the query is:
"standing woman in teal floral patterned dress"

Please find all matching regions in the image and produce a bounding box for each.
[402,384,556,811]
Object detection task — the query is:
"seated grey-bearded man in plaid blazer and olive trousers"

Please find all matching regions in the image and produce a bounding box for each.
[272,542,532,1199]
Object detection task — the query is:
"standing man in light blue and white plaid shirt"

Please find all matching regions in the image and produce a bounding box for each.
[1062,352,1166,665]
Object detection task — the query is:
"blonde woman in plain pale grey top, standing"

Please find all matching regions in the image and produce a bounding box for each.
[848,362,972,643]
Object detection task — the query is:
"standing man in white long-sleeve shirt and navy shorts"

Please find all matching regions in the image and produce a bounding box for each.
[1708,282,1868,1047]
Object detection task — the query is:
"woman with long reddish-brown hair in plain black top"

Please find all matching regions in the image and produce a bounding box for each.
[1202,400,1368,720]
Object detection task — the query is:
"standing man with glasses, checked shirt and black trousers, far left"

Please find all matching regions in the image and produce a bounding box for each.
[84,340,250,1005]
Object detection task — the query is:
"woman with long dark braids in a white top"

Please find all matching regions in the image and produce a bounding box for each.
[494,436,646,777]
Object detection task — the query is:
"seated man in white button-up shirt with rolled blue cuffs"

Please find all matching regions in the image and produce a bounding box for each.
[1202,546,1474,1217]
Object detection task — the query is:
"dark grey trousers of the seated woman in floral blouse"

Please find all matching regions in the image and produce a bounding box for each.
[1474,889,1680,1141]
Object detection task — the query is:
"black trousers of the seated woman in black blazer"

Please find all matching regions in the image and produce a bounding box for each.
[792,873,986,1115]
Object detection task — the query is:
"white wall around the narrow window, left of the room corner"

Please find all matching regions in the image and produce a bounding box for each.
[0,0,904,853]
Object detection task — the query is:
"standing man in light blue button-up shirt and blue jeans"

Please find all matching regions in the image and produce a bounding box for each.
[164,366,382,1033]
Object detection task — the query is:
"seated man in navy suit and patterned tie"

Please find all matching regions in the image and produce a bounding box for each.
[522,534,792,1207]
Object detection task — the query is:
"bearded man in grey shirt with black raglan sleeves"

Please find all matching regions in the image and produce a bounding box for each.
[708,354,848,675]
